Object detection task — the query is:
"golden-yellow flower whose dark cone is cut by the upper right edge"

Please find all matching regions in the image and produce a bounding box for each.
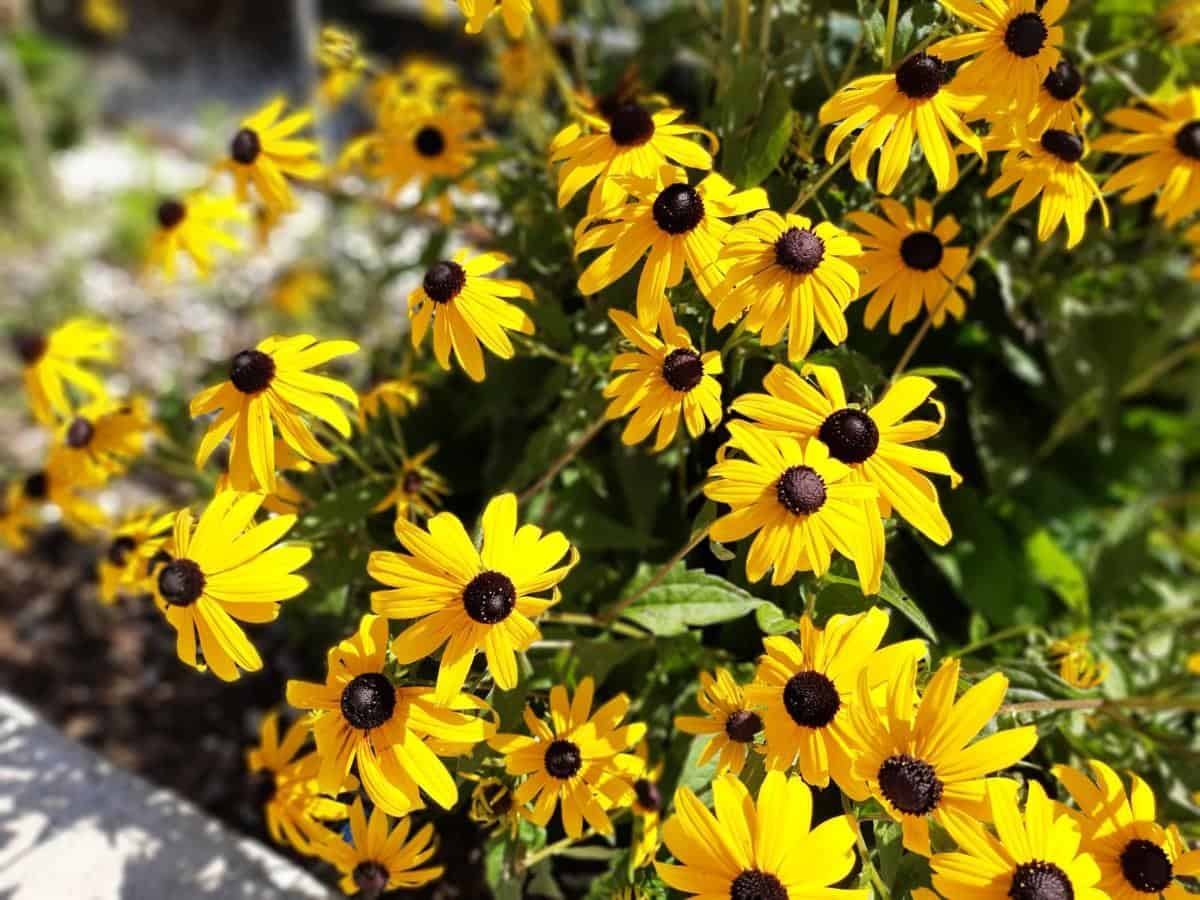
[1096,88,1200,226]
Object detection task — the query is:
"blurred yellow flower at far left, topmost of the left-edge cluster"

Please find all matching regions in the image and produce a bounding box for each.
[12,319,116,425]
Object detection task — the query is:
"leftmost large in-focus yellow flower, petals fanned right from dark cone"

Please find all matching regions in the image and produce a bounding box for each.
[155,491,312,682]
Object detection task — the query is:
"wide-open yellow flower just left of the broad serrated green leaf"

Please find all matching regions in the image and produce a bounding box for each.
[367,493,580,698]
